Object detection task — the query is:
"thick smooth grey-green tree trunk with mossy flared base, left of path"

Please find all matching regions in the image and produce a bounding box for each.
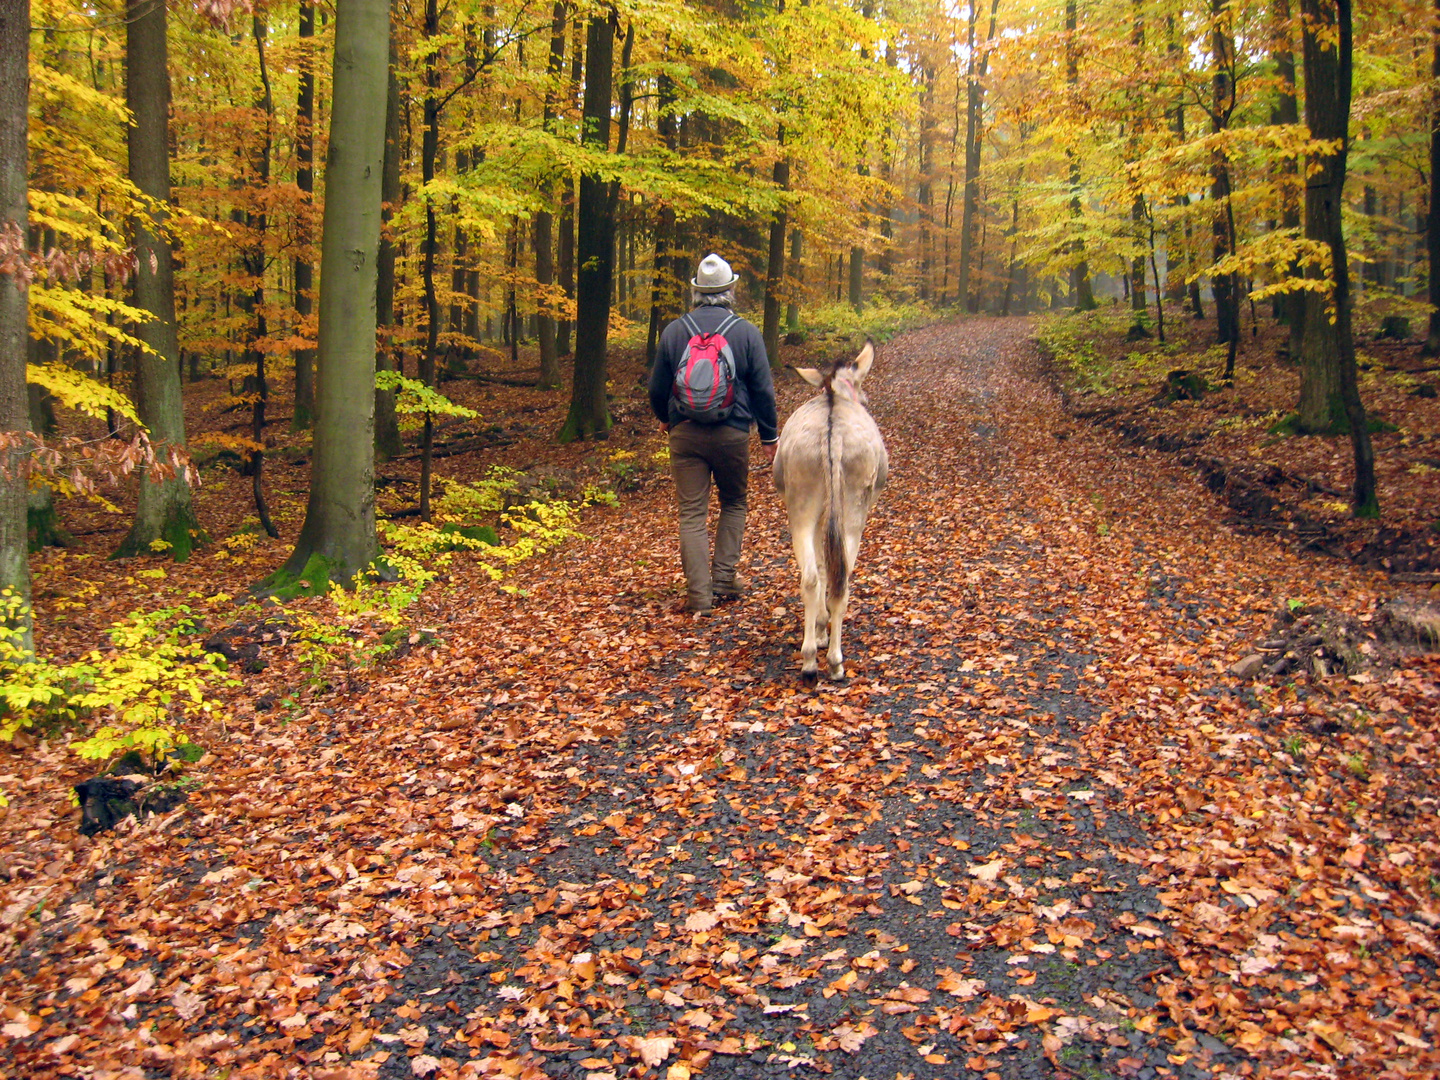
[269,0,390,588]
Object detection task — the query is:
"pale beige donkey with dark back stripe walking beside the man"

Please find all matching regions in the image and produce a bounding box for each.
[775,341,890,685]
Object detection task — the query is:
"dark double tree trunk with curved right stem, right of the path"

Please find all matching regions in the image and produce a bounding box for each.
[1300,0,1380,517]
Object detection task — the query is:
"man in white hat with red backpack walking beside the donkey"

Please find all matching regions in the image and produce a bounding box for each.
[649,253,779,615]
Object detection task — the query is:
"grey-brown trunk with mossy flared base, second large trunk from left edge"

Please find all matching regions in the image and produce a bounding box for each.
[115,0,204,562]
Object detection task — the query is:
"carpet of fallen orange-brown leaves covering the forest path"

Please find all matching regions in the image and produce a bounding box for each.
[0,320,1440,1080]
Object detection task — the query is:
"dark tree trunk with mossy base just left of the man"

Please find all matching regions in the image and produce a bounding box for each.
[557,10,615,442]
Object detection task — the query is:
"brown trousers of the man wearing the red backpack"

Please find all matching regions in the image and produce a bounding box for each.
[670,420,750,611]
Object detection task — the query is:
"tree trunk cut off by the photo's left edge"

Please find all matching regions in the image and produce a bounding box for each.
[0,0,35,657]
